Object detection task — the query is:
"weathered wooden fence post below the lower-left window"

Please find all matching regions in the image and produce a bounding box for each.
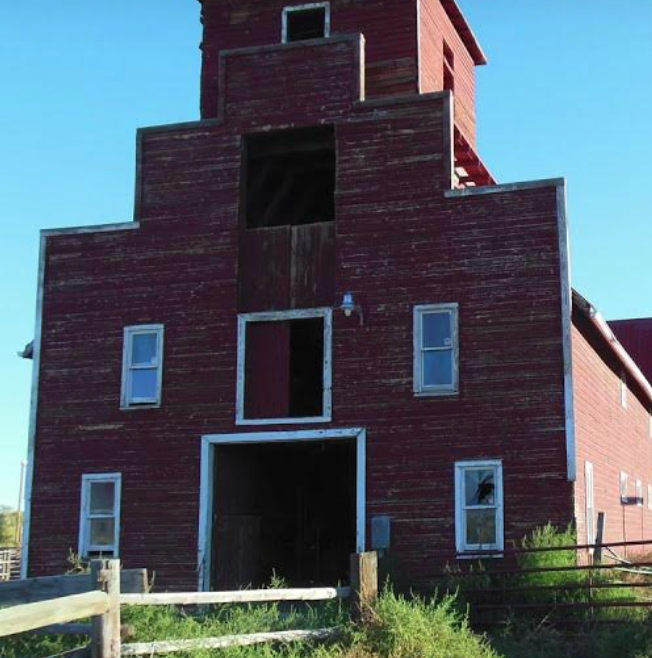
[91,560,122,658]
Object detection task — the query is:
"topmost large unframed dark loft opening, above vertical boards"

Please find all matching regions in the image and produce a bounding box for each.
[243,126,335,228]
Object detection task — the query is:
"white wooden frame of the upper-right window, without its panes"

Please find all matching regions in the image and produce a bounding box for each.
[413,303,460,397]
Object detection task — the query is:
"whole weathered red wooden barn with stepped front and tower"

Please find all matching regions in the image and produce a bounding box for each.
[19,0,652,589]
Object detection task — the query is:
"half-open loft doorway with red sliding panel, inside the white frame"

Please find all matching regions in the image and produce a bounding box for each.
[244,317,324,420]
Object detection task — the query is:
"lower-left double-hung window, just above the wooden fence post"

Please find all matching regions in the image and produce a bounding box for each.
[79,473,122,558]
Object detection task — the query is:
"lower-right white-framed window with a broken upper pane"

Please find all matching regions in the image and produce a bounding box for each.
[455,460,504,553]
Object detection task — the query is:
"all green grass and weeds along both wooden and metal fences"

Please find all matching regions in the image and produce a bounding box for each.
[5,526,652,658]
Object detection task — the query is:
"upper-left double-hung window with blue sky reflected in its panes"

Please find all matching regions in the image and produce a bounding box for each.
[121,324,163,408]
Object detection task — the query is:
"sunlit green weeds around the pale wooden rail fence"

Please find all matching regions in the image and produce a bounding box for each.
[0,590,499,658]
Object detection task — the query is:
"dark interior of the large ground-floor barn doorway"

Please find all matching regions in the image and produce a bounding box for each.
[212,440,356,590]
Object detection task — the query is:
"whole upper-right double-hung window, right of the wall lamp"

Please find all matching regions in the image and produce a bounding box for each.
[414,304,459,395]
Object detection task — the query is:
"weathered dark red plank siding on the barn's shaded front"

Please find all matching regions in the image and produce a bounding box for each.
[24,0,652,589]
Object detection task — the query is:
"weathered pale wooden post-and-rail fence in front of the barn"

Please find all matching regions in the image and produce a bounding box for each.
[0,553,378,658]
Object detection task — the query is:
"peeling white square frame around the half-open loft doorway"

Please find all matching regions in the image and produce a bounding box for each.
[235,308,333,425]
